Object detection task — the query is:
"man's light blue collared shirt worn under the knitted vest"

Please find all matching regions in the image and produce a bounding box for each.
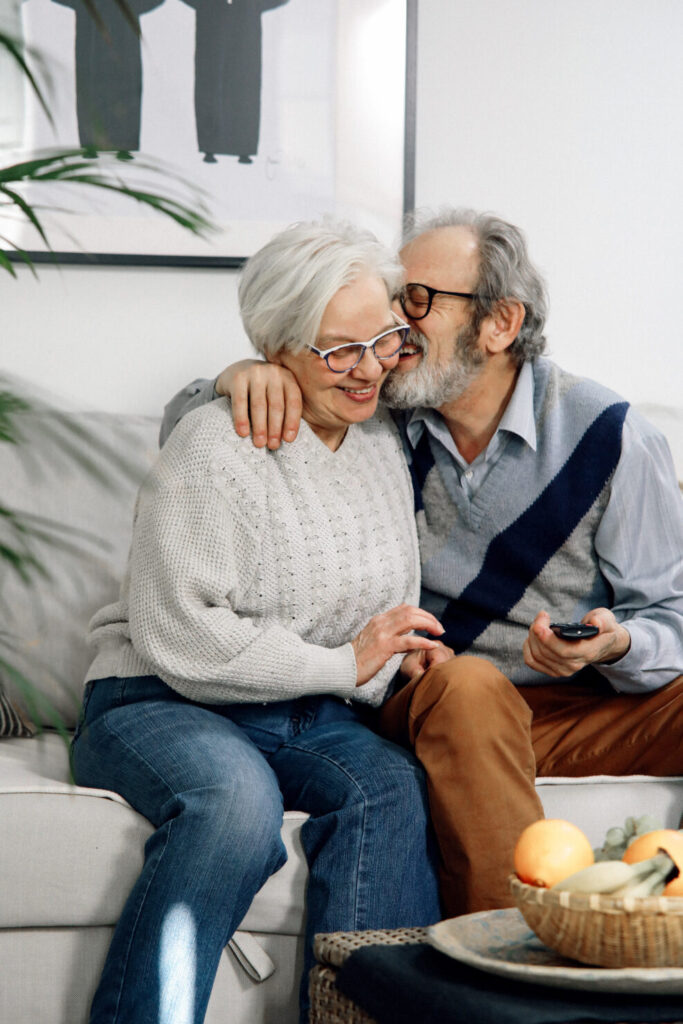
[405,362,683,692]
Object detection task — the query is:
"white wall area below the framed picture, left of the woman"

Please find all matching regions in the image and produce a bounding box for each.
[0,265,248,415]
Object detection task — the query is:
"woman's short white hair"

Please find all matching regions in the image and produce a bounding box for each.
[238,220,401,355]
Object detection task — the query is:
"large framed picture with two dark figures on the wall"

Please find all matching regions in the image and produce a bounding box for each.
[2,0,417,266]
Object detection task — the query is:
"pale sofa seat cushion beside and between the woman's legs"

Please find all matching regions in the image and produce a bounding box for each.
[0,732,307,935]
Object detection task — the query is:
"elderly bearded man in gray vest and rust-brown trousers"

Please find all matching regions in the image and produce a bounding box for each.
[163,210,683,915]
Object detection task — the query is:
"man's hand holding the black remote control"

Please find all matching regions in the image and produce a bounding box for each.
[524,608,631,677]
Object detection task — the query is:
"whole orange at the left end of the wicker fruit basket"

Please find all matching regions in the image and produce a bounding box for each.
[514,818,595,889]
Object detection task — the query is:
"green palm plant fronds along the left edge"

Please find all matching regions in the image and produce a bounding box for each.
[0,0,213,743]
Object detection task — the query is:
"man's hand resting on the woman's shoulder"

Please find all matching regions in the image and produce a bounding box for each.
[215,359,301,450]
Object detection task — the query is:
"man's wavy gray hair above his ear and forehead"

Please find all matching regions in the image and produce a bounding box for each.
[402,207,548,366]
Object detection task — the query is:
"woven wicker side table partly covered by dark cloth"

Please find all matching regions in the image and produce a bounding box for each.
[308,928,427,1024]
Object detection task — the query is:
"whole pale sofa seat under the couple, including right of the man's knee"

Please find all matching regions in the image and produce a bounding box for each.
[0,732,683,935]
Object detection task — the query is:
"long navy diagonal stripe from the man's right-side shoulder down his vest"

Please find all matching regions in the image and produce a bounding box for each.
[439,402,629,653]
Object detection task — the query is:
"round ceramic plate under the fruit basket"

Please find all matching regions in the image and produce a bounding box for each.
[427,907,683,995]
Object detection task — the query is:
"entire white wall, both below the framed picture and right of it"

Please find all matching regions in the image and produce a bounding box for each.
[0,0,683,413]
